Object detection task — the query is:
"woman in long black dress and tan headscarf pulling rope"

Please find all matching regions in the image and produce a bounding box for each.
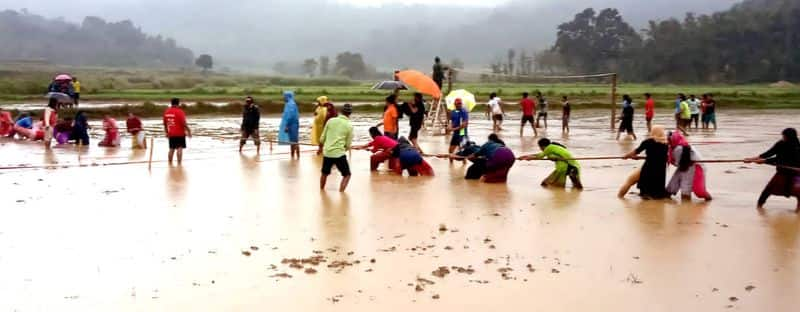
[617,126,669,199]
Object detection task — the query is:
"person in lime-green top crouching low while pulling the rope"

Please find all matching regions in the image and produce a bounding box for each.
[519,139,583,190]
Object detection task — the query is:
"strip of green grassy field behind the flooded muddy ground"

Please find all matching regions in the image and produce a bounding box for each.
[0,64,800,114]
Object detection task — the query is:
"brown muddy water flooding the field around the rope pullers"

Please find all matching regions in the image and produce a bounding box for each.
[0,111,800,311]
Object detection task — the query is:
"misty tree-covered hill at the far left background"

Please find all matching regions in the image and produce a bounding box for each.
[0,10,195,67]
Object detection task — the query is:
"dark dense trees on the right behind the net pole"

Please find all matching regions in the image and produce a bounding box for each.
[549,0,800,83]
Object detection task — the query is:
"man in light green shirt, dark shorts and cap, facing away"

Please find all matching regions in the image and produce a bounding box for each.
[317,104,353,192]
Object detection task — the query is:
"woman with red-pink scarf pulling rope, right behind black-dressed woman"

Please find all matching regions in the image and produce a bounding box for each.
[667,131,711,201]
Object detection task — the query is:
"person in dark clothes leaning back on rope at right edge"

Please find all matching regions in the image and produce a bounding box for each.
[745,128,800,213]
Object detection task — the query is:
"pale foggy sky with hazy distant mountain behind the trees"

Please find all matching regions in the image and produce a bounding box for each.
[0,0,737,69]
